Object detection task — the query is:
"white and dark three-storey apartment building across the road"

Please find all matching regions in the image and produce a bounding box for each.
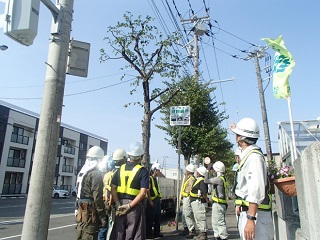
[0,101,108,196]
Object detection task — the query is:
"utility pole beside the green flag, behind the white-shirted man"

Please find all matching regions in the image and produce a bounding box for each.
[249,49,272,161]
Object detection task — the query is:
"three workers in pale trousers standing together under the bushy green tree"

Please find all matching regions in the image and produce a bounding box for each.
[181,161,228,240]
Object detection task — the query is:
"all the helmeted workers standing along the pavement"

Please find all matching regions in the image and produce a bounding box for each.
[76,118,274,240]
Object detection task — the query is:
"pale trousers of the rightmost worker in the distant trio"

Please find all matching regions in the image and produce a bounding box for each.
[211,202,228,239]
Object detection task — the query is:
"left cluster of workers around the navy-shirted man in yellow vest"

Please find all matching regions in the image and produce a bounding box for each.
[75,142,163,240]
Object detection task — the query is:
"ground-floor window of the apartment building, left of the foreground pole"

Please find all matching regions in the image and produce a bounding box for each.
[2,172,23,194]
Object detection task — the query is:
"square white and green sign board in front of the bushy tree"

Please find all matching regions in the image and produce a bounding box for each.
[170,106,190,126]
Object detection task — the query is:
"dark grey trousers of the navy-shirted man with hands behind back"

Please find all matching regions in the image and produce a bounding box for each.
[113,199,146,240]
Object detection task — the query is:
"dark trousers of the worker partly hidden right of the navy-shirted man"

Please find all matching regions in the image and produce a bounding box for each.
[146,197,161,237]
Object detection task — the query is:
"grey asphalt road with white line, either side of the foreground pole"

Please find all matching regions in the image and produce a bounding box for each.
[0,197,76,240]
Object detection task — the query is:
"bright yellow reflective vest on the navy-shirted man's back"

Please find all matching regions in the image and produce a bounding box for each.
[117,164,142,196]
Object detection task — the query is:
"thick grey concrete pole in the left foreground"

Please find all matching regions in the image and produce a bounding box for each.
[21,0,74,240]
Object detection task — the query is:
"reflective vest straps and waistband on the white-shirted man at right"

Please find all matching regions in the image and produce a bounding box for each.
[237,149,272,210]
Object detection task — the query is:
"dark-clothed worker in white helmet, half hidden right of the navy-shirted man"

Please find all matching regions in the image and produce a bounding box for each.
[146,163,163,239]
